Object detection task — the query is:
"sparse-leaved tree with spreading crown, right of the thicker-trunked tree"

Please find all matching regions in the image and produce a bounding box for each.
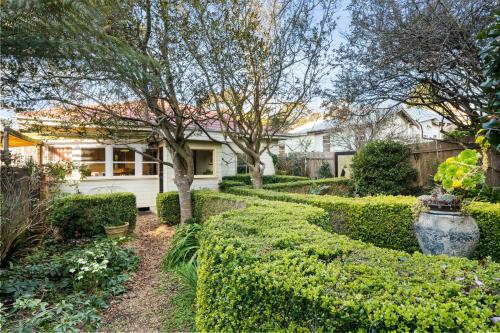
[181,0,336,188]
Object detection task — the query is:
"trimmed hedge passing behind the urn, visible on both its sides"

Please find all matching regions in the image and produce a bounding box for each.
[229,187,500,261]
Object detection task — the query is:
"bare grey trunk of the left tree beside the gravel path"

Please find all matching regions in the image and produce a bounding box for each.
[171,148,194,224]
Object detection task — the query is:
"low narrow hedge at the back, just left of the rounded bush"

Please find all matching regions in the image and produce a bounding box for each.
[264,178,354,197]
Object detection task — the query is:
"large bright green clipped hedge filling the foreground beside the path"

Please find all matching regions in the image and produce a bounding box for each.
[195,192,500,332]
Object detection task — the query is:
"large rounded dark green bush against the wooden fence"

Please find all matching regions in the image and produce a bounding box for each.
[352,140,417,195]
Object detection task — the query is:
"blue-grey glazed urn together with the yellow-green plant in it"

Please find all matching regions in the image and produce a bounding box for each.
[415,149,487,257]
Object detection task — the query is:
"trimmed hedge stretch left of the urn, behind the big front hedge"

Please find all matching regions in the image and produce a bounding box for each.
[230,188,419,252]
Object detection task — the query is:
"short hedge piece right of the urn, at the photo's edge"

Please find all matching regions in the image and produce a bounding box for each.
[465,202,500,262]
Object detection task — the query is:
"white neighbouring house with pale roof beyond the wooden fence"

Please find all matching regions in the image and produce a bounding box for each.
[280,108,454,156]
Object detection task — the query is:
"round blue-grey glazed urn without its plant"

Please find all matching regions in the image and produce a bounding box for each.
[415,210,479,257]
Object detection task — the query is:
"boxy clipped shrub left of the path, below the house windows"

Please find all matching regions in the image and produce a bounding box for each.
[47,193,137,239]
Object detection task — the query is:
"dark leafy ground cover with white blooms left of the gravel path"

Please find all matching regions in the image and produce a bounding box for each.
[0,239,138,332]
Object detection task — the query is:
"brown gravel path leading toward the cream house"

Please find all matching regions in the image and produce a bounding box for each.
[101,213,175,333]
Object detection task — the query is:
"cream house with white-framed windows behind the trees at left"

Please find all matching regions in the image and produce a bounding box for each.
[6,107,278,209]
